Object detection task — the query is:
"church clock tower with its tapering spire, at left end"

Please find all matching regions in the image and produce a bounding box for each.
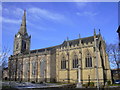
[13,10,31,55]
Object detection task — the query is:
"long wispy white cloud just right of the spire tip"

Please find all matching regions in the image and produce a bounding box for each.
[28,7,65,21]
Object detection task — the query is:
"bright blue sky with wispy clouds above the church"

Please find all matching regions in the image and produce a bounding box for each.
[2,2,118,54]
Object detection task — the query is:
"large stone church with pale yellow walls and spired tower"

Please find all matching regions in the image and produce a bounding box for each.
[8,11,111,84]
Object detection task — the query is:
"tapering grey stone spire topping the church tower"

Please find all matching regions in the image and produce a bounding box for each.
[19,10,27,35]
